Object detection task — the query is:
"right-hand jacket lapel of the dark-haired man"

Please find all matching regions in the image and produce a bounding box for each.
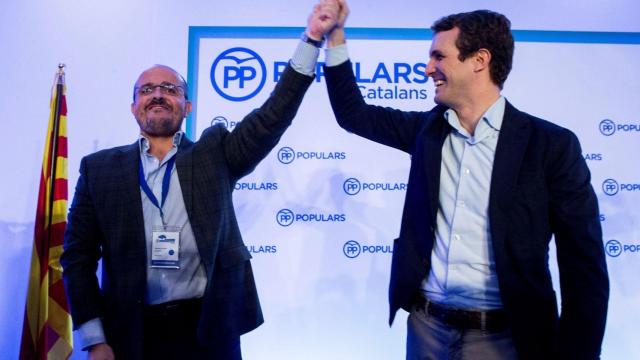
[489,102,531,250]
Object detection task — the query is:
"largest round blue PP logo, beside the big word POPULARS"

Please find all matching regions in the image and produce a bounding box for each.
[210,47,267,101]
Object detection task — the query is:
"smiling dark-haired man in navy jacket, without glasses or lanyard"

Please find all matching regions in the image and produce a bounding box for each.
[316,0,609,359]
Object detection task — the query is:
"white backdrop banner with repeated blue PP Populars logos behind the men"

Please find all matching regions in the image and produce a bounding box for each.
[187,27,640,359]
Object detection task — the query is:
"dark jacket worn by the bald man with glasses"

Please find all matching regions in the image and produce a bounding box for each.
[61,67,312,359]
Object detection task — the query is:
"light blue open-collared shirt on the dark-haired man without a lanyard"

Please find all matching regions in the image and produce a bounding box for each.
[422,96,505,310]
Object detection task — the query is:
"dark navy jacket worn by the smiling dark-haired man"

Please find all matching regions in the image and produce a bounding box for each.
[325,62,609,359]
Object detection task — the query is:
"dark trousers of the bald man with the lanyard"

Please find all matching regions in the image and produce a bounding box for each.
[143,299,242,360]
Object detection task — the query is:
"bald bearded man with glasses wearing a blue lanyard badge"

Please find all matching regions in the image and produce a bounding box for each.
[61,2,337,360]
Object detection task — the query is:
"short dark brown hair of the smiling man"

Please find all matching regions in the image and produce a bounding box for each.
[431,10,513,89]
